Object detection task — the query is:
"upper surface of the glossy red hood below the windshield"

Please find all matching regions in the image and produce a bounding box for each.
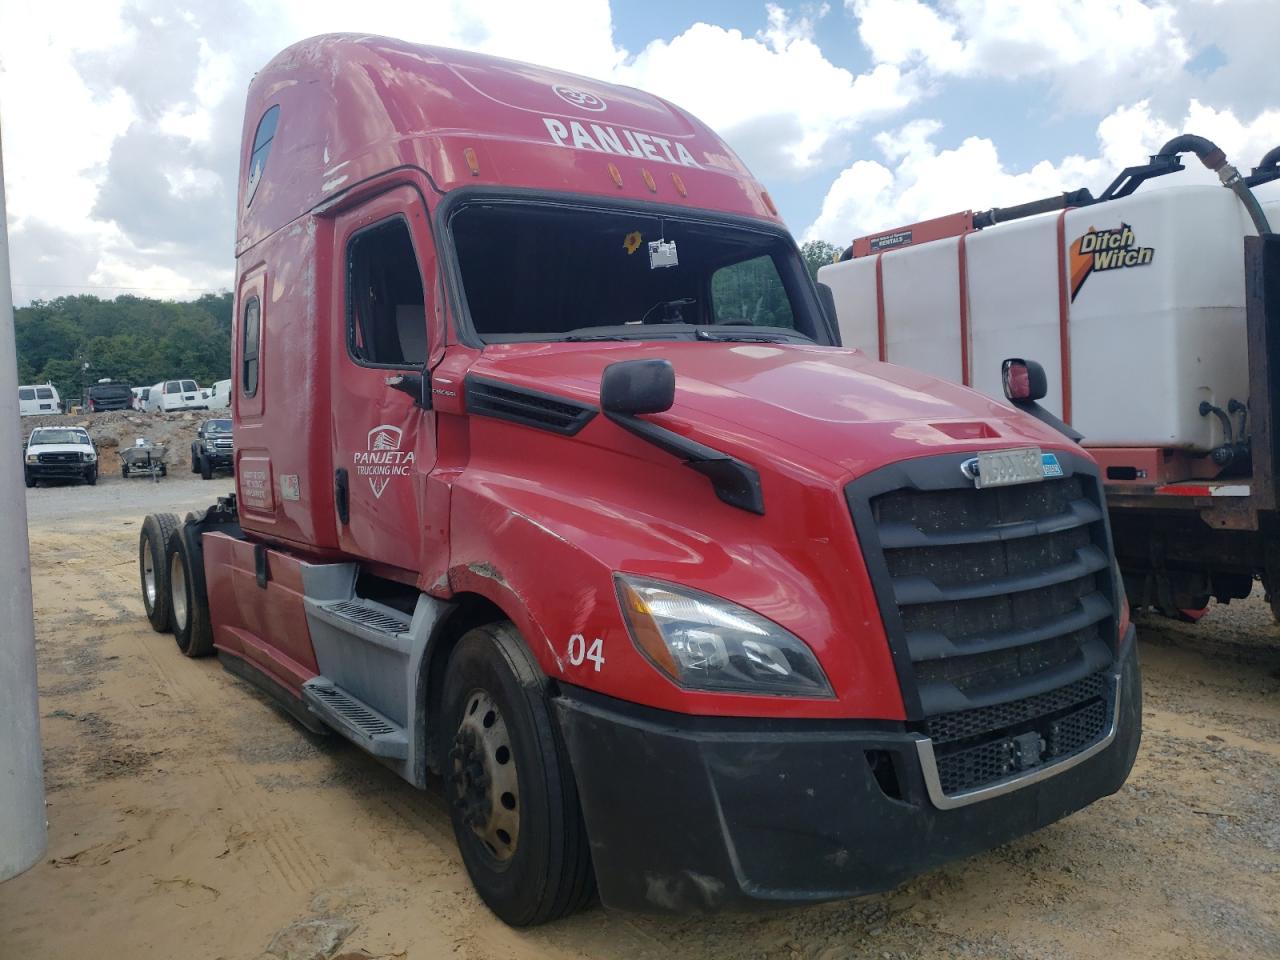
[471,342,1064,476]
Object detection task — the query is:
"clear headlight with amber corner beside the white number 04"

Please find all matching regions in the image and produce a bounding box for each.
[617,573,835,696]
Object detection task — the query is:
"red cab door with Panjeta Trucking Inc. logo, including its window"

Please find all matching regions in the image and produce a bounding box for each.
[330,187,436,575]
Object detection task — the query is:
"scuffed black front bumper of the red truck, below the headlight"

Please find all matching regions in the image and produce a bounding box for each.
[556,627,1142,911]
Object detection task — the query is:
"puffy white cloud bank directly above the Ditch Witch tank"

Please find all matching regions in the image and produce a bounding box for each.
[804,100,1280,246]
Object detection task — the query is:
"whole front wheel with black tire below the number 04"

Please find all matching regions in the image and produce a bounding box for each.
[440,622,595,927]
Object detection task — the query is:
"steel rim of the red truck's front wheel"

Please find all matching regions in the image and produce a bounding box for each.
[449,690,520,863]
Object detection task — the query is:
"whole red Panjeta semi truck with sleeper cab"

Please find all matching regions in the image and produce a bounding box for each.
[140,36,1140,924]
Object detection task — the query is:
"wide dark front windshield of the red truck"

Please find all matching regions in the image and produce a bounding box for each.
[449,200,829,343]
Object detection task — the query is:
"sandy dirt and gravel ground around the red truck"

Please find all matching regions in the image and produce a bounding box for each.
[0,474,1280,960]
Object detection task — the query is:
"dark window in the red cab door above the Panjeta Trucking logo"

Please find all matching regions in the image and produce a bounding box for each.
[347,218,426,366]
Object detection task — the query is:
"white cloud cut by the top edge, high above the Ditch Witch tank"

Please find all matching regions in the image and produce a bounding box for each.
[845,0,1190,110]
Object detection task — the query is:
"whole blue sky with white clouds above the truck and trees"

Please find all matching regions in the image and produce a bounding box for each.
[0,0,1280,305]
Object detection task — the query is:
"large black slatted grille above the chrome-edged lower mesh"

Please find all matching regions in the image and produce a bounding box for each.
[849,457,1115,717]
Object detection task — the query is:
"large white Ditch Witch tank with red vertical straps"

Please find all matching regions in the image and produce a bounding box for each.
[818,182,1280,451]
